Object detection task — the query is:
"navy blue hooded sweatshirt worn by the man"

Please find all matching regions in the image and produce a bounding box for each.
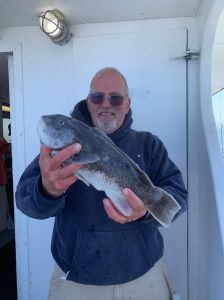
[16,100,187,285]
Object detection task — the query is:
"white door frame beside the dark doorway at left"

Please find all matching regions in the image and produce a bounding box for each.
[0,41,29,300]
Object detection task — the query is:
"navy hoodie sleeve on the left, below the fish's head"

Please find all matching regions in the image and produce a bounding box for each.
[15,156,65,219]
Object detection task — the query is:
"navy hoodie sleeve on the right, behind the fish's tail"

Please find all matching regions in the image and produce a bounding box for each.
[142,136,187,226]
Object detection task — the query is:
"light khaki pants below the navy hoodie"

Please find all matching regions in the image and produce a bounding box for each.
[48,260,172,300]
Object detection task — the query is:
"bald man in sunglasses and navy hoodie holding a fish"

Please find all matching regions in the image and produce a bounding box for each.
[16,68,187,300]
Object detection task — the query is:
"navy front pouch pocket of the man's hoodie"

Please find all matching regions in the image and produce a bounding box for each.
[67,229,153,285]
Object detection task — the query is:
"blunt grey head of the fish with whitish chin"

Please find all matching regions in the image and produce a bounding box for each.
[37,114,80,150]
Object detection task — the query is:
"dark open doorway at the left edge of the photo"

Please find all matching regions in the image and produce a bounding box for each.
[0,53,17,300]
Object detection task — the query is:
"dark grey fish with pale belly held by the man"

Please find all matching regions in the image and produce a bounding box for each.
[37,114,181,227]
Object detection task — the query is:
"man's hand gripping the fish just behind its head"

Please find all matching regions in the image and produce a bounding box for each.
[39,144,83,197]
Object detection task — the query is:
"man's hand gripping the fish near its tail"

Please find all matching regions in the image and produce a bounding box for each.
[103,188,147,224]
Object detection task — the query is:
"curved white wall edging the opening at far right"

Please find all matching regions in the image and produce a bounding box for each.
[195,0,224,300]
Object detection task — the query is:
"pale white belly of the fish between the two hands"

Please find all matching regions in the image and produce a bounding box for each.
[75,169,133,217]
